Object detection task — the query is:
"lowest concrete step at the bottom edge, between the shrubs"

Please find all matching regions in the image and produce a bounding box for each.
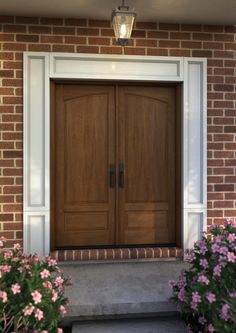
[72,318,187,333]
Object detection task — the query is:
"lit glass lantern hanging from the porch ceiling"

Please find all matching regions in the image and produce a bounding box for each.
[111,0,136,46]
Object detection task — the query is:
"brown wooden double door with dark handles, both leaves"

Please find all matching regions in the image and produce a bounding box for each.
[52,84,176,248]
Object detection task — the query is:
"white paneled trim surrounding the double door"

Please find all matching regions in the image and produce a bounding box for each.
[24,52,207,255]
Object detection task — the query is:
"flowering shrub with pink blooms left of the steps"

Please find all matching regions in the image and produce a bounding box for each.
[0,237,70,333]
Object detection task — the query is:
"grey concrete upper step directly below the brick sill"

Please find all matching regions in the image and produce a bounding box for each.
[60,261,187,324]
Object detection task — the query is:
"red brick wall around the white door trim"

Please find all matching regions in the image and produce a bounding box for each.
[0,16,236,245]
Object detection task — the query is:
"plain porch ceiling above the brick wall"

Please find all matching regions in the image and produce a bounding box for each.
[0,0,236,25]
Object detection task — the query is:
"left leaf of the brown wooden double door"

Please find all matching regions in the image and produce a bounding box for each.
[54,84,115,247]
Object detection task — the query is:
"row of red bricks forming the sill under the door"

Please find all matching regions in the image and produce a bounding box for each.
[50,247,183,262]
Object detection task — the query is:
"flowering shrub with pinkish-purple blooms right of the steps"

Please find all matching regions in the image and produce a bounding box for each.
[170,219,236,333]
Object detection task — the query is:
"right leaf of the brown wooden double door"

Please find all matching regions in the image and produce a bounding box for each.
[118,86,176,244]
